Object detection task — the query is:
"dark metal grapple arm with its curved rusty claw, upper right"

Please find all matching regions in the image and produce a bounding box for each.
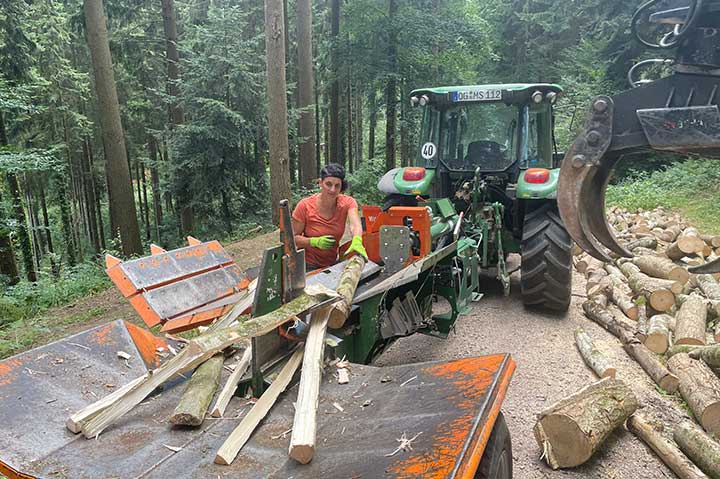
[558,0,720,268]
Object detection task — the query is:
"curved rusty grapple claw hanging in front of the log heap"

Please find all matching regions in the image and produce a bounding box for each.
[558,96,632,261]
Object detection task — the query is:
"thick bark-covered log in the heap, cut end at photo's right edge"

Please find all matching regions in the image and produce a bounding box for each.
[668,353,720,435]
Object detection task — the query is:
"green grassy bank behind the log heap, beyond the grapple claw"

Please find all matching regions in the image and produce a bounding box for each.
[607,159,720,234]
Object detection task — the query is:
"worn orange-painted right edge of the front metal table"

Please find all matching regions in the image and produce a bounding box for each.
[388,354,515,479]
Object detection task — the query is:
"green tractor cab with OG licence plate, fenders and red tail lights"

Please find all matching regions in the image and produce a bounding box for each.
[379,84,562,206]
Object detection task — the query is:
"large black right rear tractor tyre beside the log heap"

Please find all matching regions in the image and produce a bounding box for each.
[520,202,572,311]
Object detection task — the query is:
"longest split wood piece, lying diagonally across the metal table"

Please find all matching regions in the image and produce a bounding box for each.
[82,285,337,438]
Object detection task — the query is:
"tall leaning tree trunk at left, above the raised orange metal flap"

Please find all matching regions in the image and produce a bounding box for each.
[83,0,142,256]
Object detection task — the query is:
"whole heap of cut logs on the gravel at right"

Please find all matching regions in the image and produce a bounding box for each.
[535,208,720,478]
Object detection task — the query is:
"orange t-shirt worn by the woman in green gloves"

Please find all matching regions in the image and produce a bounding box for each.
[293,193,357,268]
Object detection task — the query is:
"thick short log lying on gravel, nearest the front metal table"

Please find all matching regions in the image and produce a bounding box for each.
[534,378,638,469]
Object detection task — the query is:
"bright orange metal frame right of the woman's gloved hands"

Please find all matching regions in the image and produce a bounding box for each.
[362,205,432,263]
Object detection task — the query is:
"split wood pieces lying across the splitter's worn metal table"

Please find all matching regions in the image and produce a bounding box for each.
[66,256,366,465]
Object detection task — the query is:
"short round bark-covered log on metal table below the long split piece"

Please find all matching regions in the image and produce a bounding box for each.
[169,353,225,426]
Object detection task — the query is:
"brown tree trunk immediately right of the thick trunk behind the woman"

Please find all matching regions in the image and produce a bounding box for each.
[296,0,317,187]
